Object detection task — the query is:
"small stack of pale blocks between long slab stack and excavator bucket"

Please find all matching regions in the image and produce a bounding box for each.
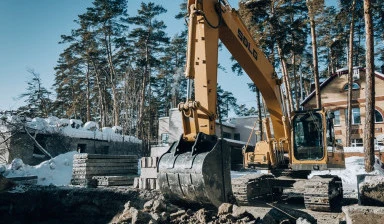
[133,157,159,190]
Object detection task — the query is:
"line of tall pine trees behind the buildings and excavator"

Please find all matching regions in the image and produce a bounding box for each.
[15,0,384,158]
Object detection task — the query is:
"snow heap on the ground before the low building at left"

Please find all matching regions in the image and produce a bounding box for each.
[3,151,77,186]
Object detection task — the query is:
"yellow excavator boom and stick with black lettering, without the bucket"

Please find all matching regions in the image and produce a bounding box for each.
[179,0,288,141]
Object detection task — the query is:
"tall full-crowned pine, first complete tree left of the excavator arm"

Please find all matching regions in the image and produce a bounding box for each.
[128,2,169,154]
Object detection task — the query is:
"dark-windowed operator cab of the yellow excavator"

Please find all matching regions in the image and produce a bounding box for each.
[292,111,325,160]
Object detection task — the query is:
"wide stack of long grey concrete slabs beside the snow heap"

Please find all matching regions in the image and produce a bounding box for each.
[71,153,138,186]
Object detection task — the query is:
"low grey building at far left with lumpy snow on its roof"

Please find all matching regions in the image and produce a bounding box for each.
[0,119,142,165]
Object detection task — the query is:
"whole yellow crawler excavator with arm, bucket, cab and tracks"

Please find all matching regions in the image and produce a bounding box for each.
[158,0,345,211]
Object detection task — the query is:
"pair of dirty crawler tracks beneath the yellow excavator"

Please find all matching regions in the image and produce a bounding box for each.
[232,174,343,212]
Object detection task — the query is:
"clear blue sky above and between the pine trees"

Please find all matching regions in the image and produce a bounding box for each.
[0,0,255,114]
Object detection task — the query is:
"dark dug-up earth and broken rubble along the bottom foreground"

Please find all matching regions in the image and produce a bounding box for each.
[0,185,355,223]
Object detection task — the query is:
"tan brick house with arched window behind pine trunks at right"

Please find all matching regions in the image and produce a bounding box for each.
[301,67,384,147]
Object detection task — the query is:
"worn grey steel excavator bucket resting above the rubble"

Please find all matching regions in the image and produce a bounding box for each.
[157,133,233,207]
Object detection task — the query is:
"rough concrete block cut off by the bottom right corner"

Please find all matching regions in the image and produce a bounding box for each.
[342,205,384,224]
